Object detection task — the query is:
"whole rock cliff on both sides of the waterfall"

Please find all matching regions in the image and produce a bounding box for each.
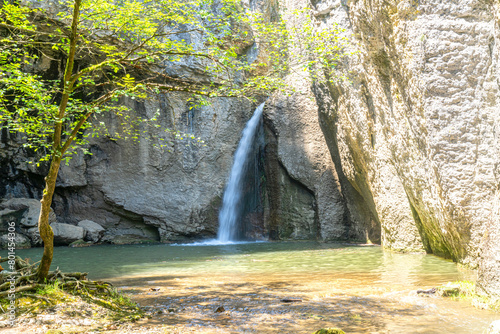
[0,0,500,297]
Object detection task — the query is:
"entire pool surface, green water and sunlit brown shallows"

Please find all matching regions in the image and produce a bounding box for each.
[0,242,498,334]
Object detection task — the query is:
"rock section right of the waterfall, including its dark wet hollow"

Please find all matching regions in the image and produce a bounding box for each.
[266,95,379,242]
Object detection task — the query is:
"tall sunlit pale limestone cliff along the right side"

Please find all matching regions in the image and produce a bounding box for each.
[291,0,500,295]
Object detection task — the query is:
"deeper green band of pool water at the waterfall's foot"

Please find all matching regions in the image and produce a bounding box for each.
[0,242,460,285]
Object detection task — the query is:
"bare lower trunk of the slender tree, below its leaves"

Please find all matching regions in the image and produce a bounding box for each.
[37,153,61,281]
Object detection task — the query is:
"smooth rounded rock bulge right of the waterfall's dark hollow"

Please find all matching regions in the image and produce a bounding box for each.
[266,92,345,240]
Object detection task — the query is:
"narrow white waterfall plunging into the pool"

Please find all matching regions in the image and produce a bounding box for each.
[217,103,264,243]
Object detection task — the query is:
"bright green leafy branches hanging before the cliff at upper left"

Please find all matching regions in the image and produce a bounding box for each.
[0,0,354,161]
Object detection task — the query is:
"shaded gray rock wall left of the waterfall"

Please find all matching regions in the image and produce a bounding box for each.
[55,94,253,242]
